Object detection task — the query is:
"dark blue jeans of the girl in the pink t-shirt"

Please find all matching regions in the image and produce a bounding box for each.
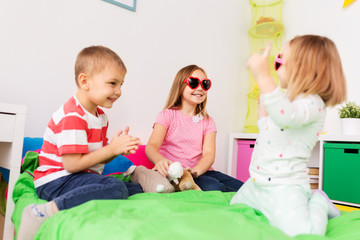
[194,170,244,192]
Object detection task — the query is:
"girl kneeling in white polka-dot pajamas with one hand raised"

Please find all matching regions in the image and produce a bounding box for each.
[231,35,346,236]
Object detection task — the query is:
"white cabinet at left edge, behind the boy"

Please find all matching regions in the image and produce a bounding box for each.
[0,103,26,240]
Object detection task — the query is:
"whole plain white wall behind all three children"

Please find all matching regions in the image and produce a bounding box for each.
[0,0,360,171]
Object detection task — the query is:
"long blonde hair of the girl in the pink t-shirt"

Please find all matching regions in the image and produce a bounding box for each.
[164,65,209,118]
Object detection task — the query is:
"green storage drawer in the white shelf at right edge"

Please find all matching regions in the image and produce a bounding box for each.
[323,143,360,204]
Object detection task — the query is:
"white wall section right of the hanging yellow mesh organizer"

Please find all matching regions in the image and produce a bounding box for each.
[283,0,360,134]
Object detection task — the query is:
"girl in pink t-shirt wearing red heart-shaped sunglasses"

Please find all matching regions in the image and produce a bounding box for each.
[146,65,243,192]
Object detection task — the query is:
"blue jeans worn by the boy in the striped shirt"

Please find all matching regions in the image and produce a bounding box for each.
[36,172,143,210]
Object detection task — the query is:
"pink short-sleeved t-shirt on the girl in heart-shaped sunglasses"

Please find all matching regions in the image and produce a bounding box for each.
[155,109,216,168]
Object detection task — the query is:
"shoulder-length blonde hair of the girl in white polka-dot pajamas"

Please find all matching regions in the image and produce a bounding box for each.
[285,35,346,106]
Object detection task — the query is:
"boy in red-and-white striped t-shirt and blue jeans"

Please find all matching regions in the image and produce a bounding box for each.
[17,46,142,239]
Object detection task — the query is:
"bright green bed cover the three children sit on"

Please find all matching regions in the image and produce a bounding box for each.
[12,139,360,240]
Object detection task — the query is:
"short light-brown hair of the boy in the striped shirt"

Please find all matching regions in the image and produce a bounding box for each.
[75,46,127,85]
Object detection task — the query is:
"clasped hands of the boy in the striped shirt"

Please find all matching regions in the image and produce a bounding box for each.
[109,127,141,156]
